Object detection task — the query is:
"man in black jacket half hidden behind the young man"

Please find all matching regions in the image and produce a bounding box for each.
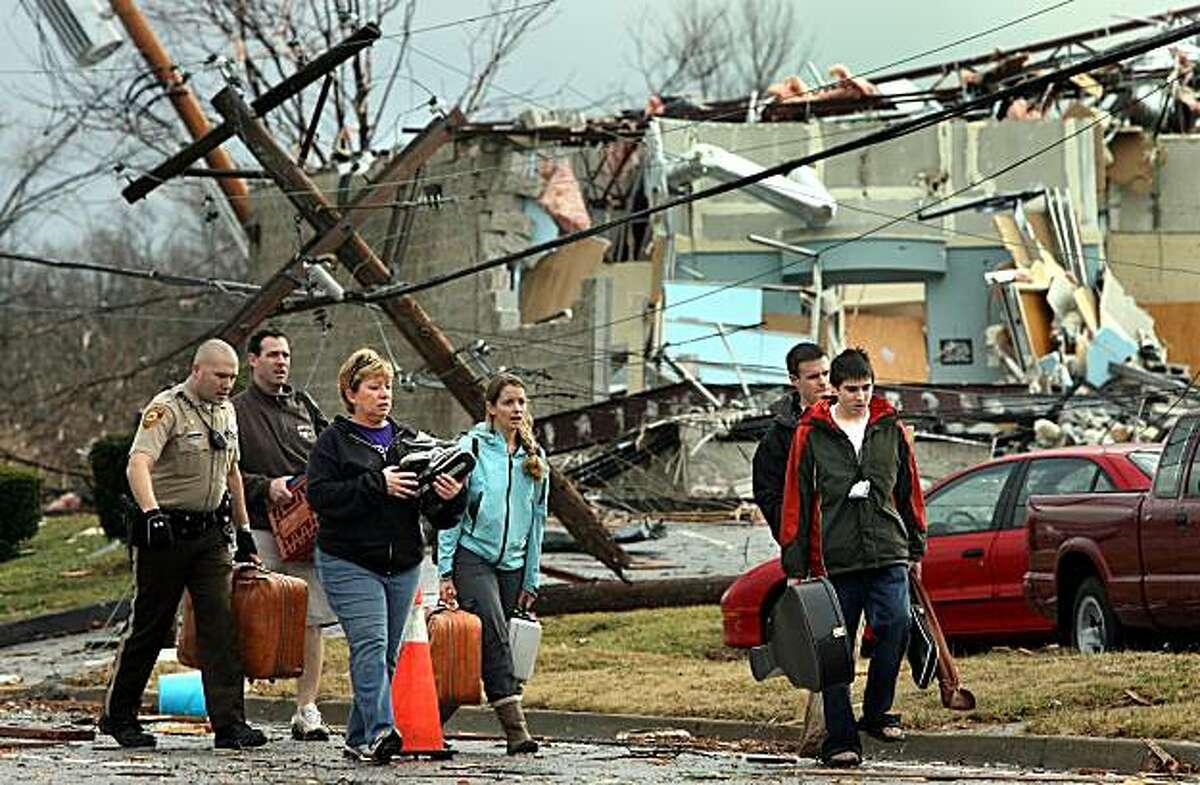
[754,341,829,539]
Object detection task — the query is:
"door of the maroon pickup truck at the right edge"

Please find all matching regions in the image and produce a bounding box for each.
[1141,418,1200,630]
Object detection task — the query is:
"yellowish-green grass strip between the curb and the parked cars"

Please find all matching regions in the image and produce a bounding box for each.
[44,544,1200,739]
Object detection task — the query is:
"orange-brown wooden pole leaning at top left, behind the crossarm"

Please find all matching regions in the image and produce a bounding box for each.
[108,0,250,226]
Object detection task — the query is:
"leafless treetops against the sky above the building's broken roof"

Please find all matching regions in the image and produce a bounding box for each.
[630,0,811,98]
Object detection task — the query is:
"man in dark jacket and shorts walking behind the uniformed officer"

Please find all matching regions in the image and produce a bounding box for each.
[233,326,337,742]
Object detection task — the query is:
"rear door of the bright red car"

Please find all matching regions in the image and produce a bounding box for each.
[991,457,1115,633]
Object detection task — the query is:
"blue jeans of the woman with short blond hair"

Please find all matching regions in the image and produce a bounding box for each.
[313,549,421,745]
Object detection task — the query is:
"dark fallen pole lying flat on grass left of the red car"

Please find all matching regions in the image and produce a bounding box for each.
[535,575,737,616]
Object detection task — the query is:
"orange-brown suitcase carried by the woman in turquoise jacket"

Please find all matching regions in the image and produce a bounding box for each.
[426,605,484,717]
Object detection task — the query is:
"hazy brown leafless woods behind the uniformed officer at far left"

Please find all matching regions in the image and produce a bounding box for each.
[0,211,243,466]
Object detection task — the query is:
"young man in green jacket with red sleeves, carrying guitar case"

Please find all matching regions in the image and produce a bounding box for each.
[779,349,925,766]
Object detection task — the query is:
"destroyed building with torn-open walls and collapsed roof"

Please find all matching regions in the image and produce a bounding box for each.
[243,8,1200,516]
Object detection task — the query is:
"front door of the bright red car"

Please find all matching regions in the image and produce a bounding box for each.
[922,461,1019,636]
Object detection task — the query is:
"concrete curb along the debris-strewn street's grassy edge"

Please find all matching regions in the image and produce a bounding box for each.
[24,687,1200,774]
